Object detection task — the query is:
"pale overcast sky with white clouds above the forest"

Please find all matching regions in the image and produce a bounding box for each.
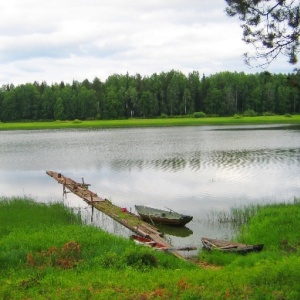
[0,0,293,85]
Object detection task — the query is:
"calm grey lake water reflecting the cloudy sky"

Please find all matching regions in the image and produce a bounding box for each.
[0,125,300,253]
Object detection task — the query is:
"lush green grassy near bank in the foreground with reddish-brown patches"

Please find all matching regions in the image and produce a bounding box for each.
[0,199,300,299]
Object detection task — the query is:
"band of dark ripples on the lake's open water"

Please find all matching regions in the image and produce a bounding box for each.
[111,149,300,172]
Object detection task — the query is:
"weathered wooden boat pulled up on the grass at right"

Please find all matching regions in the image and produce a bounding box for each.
[201,238,264,253]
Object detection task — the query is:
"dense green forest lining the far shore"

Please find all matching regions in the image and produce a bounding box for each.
[0,70,300,122]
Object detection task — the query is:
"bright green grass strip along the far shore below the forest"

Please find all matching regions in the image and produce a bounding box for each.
[0,115,300,130]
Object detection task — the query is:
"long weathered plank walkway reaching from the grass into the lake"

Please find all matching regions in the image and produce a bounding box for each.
[46,171,185,259]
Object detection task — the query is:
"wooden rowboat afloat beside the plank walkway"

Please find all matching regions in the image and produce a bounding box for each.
[135,205,193,226]
